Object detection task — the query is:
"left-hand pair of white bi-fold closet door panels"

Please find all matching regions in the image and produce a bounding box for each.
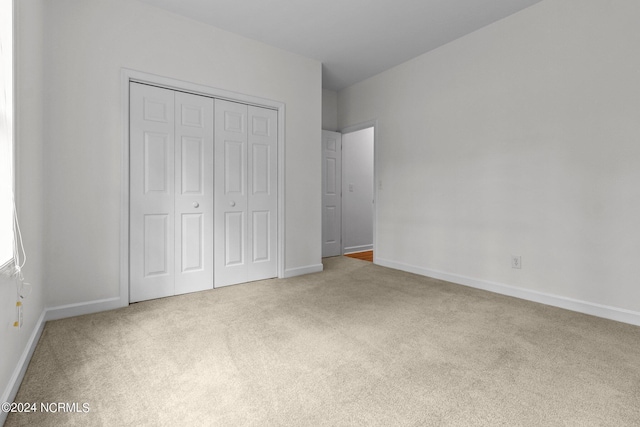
[129,83,213,302]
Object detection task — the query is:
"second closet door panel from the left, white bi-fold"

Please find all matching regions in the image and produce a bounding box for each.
[175,92,213,294]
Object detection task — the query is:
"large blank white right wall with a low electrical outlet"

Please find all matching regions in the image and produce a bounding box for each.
[338,0,640,319]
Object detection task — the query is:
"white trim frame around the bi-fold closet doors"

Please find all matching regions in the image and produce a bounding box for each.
[120,68,284,307]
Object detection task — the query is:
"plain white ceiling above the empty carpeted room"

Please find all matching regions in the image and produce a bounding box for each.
[141,0,541,90]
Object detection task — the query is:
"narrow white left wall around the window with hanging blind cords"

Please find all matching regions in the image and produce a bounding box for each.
[0,0,44,414]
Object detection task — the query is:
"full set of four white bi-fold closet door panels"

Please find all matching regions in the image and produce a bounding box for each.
[129,83,277,302]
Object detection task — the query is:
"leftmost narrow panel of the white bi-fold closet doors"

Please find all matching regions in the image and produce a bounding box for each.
[129,83,175,302]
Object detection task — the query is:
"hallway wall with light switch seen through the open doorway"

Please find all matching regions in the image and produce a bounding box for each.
[342,127,373,253]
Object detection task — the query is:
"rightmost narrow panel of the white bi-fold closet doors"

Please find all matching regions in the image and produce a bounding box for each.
[247,106,278,281]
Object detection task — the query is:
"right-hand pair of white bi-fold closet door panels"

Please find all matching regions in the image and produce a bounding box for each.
[214,99,277,287]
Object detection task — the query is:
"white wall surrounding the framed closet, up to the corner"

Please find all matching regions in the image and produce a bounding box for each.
[45,0,321,306]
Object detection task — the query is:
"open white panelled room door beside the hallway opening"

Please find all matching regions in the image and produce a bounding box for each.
[322,130,342,257]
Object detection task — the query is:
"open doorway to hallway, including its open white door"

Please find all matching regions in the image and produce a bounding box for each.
[322,124,375,259]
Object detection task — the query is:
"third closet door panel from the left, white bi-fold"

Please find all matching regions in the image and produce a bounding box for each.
[214,99,248,287]
